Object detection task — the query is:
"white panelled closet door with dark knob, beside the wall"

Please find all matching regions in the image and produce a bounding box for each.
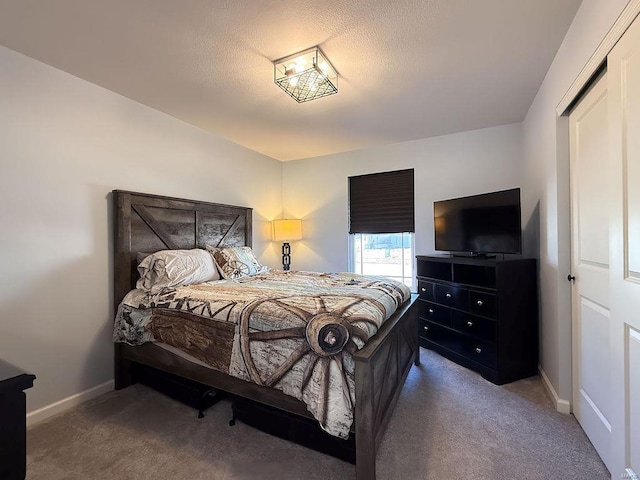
[569,70,614,469]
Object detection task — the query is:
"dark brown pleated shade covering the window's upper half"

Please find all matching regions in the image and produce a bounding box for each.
[349,168,415,233]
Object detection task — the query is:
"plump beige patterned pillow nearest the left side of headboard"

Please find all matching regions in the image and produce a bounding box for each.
[136,248,220,293]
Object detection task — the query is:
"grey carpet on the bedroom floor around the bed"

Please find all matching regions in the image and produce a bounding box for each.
[27,349,610,480]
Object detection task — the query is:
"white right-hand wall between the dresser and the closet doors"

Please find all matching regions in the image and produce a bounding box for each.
[523,0,627,402]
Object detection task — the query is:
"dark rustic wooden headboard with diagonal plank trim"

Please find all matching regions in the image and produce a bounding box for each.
[112,190,253,311]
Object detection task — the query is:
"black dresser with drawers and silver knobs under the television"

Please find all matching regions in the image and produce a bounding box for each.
[416,255,538,385]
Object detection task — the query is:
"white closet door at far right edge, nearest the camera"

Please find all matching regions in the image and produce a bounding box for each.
[607,14,640,478]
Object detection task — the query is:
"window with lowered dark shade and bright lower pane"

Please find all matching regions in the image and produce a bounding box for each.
[349,169,415,287]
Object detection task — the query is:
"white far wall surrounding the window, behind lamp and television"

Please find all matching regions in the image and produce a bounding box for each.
[282,124,522,272]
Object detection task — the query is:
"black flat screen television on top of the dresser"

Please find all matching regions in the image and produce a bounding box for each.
[433,188,522,255]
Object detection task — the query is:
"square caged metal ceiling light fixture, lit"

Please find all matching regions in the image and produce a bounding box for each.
[273,47,338,103]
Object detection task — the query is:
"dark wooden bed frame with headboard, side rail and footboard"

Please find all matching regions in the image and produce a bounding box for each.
[112,190,420,480]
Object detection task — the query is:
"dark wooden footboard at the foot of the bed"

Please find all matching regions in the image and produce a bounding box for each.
[354,294,420,480]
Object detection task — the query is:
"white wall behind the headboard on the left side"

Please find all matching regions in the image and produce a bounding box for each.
[0,47,282,411]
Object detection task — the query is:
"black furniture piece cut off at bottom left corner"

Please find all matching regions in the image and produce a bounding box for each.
[0,360,36,480]
